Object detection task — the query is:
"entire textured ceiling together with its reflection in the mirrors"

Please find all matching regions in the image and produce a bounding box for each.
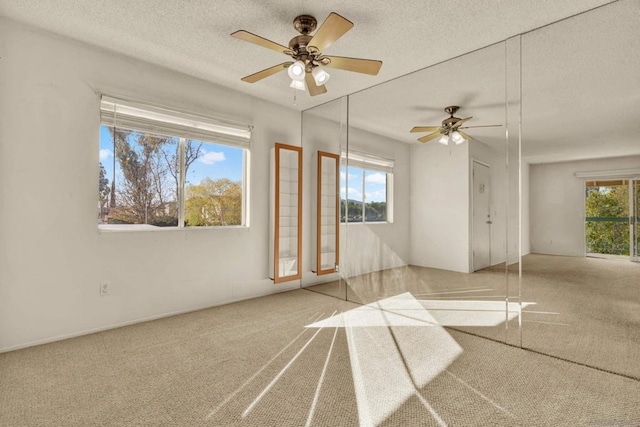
[0,0,640,162]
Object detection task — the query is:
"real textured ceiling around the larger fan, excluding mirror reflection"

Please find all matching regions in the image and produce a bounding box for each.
[0,0,610,110]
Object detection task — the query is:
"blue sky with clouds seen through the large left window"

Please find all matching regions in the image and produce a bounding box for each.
[100,125,243,189]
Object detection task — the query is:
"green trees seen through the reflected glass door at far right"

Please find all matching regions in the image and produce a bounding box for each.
[585,185,629,255]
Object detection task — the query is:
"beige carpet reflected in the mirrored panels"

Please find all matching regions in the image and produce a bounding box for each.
[310,254,640,378]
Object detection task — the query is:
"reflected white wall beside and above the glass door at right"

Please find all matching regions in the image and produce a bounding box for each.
[529,156,640,256]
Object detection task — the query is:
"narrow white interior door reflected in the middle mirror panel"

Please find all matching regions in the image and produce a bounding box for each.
[471,161,491,271]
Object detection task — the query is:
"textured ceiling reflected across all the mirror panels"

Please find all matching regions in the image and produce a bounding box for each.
[308,0,640,166]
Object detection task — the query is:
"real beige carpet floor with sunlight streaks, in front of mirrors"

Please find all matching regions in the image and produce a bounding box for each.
[0,290,640,426]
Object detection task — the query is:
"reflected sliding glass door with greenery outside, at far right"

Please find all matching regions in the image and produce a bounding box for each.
[585,179,639,261]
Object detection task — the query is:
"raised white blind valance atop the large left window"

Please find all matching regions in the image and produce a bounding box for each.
[100,95,253,148]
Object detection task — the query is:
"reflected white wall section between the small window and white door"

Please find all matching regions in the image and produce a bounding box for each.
[410,142,470,273]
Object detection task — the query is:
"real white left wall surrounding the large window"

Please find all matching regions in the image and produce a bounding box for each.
[0,19,300,351]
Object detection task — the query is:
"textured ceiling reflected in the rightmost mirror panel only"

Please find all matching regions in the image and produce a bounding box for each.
[522,0,640,166]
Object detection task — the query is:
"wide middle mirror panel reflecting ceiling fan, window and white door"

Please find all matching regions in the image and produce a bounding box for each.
[341,43,510,341]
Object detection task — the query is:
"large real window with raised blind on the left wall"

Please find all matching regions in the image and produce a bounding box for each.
[98,97,251,229]
